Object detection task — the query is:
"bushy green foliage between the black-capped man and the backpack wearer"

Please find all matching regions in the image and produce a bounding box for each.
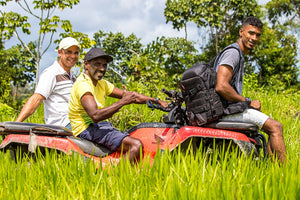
[94,31,198,95]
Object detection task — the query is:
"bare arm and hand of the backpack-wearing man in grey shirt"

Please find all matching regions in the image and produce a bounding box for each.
[216,65,260,110]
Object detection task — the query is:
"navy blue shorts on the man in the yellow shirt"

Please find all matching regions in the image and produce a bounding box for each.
[78,121,129,151]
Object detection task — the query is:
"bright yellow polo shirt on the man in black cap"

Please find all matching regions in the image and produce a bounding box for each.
[69,73,114,136]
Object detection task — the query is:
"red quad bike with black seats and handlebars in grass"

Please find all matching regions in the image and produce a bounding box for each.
[0,89,267,167]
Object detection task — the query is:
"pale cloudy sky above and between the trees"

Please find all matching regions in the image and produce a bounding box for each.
[1,0,202,73]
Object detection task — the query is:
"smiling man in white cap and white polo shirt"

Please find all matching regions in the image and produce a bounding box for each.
[16,37,80,128]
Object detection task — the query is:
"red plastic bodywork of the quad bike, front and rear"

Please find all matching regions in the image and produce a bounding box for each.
[0,126,250,167]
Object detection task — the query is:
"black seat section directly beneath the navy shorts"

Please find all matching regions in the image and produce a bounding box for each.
[67,136,113,157]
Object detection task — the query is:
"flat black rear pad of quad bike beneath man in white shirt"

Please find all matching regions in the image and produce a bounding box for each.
[0,122,73,136]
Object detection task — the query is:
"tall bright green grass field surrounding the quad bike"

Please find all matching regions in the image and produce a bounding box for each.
[0,91,300,200]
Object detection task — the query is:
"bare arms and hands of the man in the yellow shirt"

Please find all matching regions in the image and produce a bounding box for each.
[80,87,167,123]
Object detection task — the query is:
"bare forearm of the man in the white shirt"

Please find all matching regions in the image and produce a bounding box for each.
[16,93,45,122]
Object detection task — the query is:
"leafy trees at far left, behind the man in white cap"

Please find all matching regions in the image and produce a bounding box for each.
[0,0,92,102]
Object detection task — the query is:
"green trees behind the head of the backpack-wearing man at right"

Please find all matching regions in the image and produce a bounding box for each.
[165,0,299,89]
